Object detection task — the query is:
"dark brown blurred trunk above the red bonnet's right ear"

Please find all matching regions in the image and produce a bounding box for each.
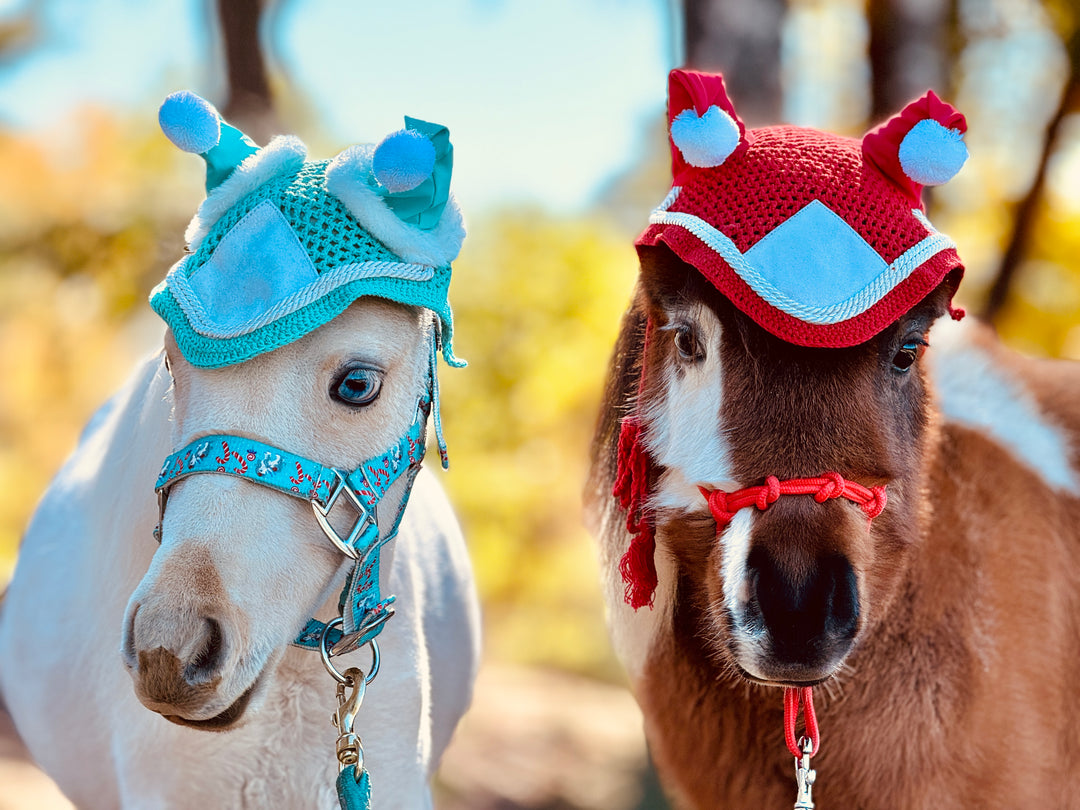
[866,0,957,121]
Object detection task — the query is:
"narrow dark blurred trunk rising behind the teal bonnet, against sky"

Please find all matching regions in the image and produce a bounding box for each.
[216,0,280,144]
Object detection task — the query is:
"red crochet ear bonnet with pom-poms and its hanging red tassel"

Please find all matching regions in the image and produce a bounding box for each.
[616,70,968,608]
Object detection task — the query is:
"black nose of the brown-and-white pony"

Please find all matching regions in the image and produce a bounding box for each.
[745,546,859,669]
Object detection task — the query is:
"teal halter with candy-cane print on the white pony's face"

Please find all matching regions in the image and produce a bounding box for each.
[154,396,431,654]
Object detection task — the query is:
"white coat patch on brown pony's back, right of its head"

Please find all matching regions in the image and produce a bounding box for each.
[927,319,1080,492]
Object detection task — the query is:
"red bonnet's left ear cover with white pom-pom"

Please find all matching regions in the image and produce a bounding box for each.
[667,70,746,186]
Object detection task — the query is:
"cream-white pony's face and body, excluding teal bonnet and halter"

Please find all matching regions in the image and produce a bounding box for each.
[0,297,480,810]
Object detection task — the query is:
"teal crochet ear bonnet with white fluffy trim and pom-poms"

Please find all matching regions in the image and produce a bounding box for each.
[150,92,464,368]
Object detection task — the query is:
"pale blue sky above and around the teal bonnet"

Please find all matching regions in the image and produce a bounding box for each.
[0,0,674,212]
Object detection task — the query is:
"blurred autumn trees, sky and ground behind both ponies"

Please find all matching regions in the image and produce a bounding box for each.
[0,0,1080,810]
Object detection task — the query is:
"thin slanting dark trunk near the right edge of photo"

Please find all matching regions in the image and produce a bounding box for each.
[981,25,1080,323]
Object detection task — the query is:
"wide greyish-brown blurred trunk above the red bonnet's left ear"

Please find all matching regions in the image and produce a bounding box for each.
[683,0,787,124]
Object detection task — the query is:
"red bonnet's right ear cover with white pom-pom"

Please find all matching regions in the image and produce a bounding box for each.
[863,90,968,206]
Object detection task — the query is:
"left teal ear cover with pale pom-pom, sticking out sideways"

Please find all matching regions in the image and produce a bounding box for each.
[158,90,259,194]
